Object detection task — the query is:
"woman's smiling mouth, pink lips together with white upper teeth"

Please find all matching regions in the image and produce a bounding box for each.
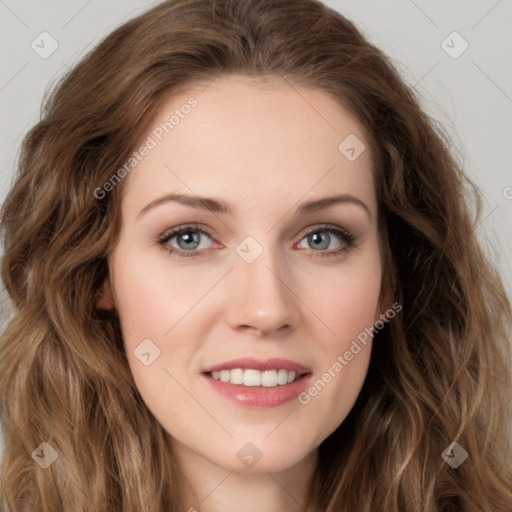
[202,358,312,408]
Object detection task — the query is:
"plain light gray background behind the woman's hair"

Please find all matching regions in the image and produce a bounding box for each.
[0,0,512,464]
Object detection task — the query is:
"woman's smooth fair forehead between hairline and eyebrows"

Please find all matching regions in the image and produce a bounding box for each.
[120,75,376,220]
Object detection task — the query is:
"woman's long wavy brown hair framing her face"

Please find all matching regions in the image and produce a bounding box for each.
[0,0,512,512]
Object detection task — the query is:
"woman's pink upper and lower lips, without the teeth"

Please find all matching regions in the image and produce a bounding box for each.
[202,358,312,408]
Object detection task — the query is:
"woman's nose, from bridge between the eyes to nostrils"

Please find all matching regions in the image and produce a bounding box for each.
[227,250,300,337]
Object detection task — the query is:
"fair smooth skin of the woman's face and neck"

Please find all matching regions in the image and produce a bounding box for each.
[99,75,386,512]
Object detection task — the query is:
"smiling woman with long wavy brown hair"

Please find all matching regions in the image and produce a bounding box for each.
[0,0,512,512]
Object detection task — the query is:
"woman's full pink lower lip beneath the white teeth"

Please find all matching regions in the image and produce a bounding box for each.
[203,374,311,408]
